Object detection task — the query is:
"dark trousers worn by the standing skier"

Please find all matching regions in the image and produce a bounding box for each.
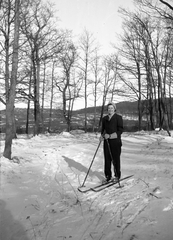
[103,139,122,178]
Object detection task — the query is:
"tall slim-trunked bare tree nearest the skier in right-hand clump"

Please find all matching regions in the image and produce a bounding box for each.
[115,9,146,130]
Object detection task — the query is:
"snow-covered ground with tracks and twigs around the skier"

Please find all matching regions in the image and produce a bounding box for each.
[0,130,173,240]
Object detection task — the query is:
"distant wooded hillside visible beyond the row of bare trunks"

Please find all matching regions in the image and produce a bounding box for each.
[0,102,145,133]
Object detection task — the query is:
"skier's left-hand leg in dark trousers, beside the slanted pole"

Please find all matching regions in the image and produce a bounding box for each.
[104,141,112,180]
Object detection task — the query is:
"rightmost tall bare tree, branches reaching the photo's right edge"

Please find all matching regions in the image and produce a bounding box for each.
[135,1,173,135]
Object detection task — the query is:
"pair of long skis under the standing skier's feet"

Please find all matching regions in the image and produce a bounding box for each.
[78,175,133,193]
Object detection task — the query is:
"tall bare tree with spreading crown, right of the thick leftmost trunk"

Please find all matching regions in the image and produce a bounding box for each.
[22,0,62,134]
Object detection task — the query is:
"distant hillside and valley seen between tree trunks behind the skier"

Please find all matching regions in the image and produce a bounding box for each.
[0,102,154,136]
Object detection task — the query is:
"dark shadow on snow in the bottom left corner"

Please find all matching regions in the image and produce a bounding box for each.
[0,199,29,240]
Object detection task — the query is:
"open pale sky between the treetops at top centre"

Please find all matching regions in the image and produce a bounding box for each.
[50,0,133,54]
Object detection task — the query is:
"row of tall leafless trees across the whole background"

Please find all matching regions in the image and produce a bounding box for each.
[0,0,173,159]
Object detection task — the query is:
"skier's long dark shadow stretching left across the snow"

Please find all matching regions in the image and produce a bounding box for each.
[62,156,104,180]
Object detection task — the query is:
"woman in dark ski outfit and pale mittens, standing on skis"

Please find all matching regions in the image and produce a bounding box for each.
[100,102,123,182]
